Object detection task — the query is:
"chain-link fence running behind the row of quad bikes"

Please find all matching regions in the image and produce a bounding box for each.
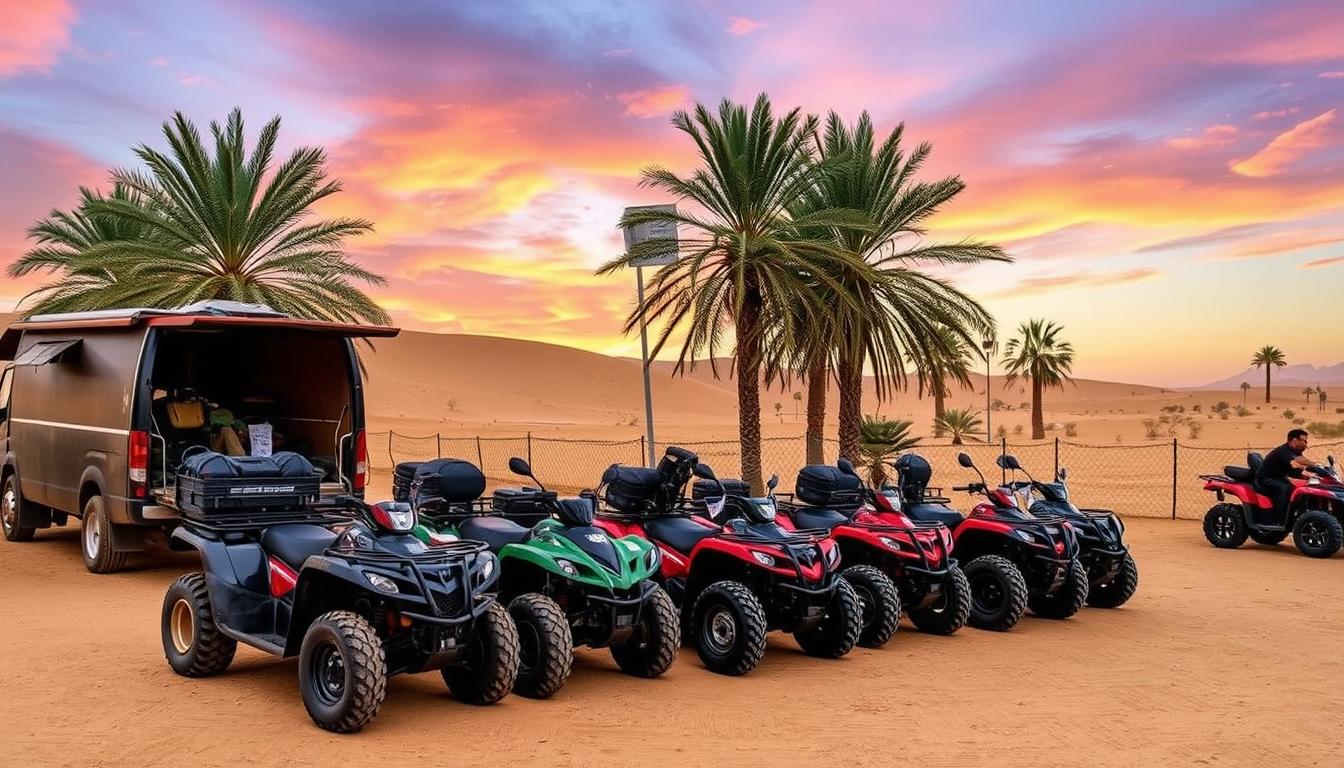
[368,432,1344,519]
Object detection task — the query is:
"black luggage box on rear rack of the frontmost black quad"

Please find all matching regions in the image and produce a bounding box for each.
[177,447,321,518]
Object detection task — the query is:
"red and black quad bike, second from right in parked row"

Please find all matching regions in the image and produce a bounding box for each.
[898,453,1087,631]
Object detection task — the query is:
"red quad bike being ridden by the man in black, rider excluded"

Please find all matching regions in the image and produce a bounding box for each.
[1199,452,1344,557]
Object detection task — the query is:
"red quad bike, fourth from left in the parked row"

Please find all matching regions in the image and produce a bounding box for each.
[780,459,970,644]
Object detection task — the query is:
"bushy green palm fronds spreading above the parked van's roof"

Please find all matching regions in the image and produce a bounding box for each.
[17,109,388,323]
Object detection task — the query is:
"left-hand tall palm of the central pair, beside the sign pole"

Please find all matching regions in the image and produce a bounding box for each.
[598,94,864,494]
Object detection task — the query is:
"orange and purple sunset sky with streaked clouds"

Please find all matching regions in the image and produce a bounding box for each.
[0,0,1344,386]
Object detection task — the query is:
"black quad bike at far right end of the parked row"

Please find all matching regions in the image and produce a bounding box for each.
[997,455,1138,608]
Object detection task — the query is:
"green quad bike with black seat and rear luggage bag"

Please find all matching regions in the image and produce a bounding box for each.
[415,457,681,698]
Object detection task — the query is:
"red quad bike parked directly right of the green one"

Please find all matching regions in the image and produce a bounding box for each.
[597,447,863,675]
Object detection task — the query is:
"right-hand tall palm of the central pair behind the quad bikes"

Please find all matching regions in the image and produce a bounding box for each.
[797,112,1008,456]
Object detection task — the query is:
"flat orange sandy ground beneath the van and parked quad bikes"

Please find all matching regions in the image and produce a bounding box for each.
[0,511,1344,768]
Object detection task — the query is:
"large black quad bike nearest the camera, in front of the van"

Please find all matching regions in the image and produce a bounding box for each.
[163,496,517,733]
